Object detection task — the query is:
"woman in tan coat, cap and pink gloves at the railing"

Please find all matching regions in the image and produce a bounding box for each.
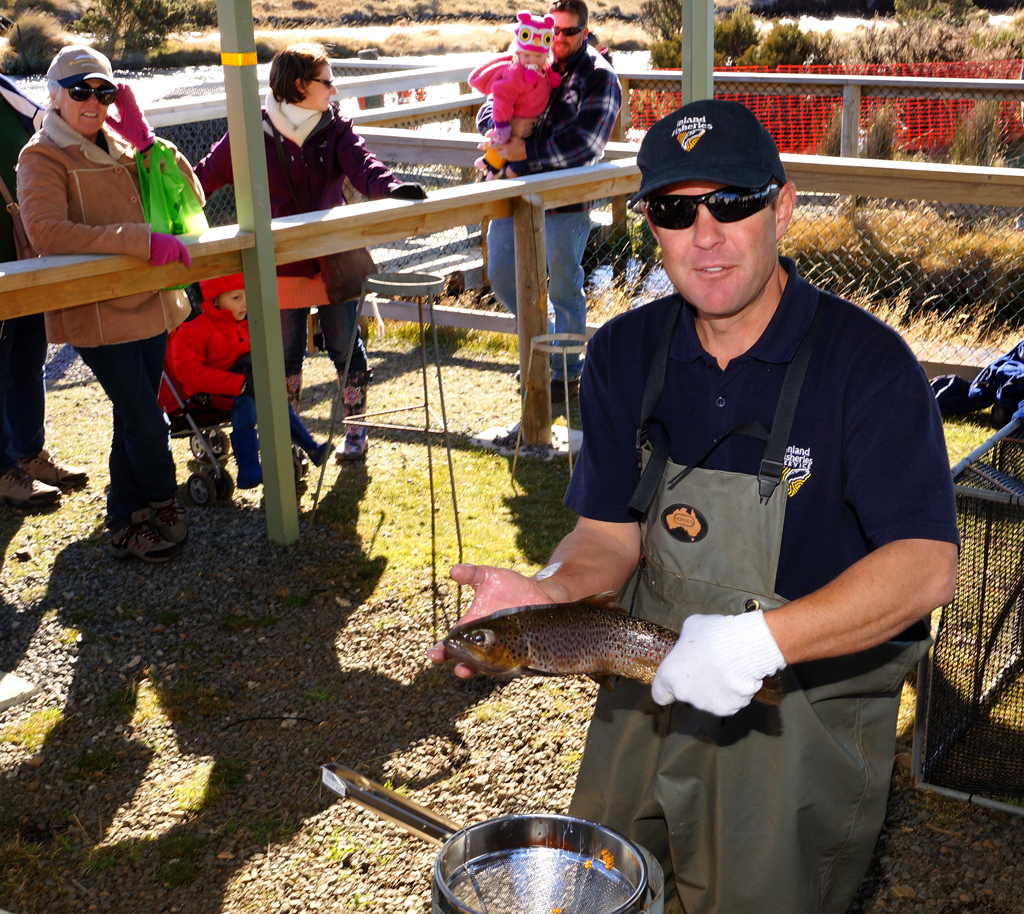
[17,46,204,562]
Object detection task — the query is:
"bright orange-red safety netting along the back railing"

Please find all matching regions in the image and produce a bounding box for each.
[630,60,1024,155]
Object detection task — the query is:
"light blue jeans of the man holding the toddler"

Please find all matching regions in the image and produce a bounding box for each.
[487,212,590,380]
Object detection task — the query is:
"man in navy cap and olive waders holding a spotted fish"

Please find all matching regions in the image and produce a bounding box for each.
[430,100,958,914]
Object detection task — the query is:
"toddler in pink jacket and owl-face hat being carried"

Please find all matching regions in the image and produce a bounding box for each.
[469,10,562,180]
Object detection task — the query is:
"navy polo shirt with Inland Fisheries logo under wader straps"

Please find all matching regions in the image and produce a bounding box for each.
[564,258,959,614]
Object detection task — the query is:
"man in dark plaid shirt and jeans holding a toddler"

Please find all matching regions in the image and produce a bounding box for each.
[476,0,623,402]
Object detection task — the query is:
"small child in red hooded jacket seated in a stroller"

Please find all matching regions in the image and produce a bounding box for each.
[168,273,328,489]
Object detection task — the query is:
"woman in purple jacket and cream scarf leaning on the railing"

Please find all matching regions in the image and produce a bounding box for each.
[196,44,427,463]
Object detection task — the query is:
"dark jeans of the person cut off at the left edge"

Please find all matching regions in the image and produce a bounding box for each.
[0,314,46,473]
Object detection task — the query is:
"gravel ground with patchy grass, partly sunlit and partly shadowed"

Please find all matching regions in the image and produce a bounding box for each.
[0,341,1024,914]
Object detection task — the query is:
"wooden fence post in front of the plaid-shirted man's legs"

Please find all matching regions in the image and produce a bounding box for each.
[512,193,551,445]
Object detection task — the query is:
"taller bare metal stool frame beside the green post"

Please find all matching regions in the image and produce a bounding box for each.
[306,273,463,628]
